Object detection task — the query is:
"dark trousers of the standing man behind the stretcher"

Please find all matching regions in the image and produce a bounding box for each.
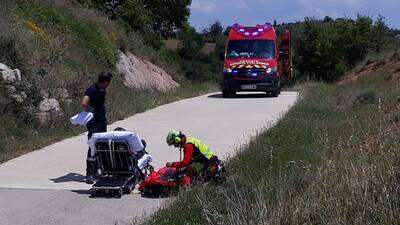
[86,119,107,176]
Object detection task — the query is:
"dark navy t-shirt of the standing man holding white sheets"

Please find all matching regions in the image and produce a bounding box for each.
[85,84,107,122]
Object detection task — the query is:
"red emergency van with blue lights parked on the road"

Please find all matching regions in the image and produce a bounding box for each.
[221,23,292,98]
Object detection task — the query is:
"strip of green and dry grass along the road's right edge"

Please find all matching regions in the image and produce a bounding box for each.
[144,56,400,225]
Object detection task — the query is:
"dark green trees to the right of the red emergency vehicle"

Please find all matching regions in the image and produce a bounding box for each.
[276,15,400,82]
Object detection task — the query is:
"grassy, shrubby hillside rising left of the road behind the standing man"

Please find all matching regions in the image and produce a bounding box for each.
[0,0,217,163]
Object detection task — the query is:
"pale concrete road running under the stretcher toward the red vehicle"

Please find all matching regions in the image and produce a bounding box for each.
[0,92,297,225]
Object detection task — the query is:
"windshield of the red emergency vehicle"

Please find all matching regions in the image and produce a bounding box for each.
[226,40,275,59]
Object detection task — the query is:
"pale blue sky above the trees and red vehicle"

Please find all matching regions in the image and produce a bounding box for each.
[189,0,400,31]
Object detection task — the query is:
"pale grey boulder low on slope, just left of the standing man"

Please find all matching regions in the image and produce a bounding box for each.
[35,99,64,126]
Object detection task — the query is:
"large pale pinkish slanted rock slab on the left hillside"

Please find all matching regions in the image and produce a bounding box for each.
[117,52,179,92]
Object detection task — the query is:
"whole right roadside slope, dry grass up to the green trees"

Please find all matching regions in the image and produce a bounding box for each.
[144,16,400,225]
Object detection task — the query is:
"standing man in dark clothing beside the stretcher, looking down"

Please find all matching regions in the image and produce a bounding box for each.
[81,72,112,184]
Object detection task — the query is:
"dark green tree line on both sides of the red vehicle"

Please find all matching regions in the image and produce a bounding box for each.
[79,0,400,82]
